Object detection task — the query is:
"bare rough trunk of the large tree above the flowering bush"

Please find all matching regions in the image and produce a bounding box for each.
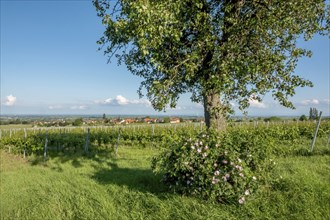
[204,93,226,131]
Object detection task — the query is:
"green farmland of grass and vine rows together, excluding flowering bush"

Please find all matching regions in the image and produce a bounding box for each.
[0,121,330,219]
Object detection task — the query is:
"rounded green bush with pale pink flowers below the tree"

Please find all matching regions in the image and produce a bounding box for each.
[152,132,272,204]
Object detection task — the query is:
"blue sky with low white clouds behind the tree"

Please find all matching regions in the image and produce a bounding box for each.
[0,0,330,116]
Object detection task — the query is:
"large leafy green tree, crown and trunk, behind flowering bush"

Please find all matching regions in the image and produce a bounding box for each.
[93,0,329,130]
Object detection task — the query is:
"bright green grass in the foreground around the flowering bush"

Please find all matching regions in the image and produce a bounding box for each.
[0,141,330,220]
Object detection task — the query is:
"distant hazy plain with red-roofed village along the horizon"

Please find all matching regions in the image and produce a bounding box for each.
[0,108,324,127]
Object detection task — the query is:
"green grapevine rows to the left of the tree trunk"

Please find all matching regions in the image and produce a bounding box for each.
[0,124,201,154]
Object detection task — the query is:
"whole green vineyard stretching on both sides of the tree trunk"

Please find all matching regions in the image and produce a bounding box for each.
[0,121,330,157]
